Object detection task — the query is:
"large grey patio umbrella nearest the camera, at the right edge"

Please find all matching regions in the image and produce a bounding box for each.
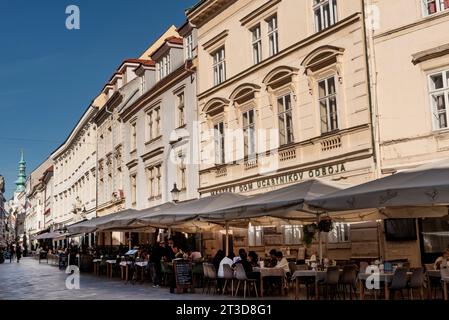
[307,159,449,220]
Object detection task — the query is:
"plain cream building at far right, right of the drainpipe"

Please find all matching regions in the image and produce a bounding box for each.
[366,0,449,262]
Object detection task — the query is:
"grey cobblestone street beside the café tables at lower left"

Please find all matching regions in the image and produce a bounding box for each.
[0,258,245,300]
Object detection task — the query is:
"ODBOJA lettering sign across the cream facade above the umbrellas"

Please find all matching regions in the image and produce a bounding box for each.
[211,163,346,195]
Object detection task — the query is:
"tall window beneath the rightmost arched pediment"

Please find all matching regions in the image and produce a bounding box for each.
[318,77,338,133]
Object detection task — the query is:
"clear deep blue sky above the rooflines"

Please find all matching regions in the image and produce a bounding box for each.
[0,0,197,199]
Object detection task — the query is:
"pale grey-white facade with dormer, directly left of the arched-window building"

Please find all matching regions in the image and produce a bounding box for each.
[120,26,198,209]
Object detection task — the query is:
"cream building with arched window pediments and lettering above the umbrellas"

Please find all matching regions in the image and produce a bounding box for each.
[188,0,376,256]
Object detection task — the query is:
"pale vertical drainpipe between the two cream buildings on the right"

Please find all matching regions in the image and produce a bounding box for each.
[361,0,382,179]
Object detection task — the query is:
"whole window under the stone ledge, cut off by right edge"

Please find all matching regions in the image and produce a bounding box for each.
[429,70,449,130]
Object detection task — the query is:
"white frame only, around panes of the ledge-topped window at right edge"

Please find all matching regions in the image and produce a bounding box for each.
[427,67,449,131]
